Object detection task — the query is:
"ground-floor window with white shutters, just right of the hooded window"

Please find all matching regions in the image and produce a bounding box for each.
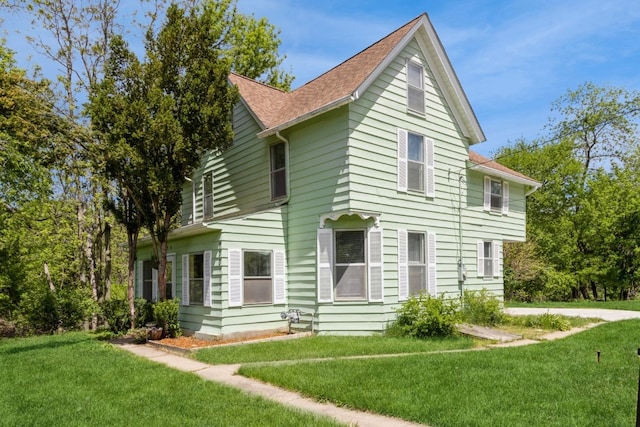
[398,230,437,300]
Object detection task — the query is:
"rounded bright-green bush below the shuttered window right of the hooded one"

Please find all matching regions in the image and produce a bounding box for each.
[387,293,458,338]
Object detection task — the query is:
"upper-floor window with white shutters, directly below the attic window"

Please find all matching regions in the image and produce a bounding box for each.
[398,129,436,197]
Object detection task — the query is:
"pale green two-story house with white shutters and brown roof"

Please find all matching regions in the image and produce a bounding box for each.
[136,14,538,337]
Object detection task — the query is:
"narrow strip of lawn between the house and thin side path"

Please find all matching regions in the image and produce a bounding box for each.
[194,335,474,364]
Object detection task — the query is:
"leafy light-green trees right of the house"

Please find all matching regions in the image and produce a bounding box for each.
[498,83,640,299]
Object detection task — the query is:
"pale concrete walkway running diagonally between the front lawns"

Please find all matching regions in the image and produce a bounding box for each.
[118,344,424,427]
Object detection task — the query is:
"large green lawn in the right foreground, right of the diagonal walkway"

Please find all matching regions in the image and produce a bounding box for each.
[240,320,640,426]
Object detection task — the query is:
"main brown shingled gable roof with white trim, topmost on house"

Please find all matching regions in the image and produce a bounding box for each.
[230,14,485,144]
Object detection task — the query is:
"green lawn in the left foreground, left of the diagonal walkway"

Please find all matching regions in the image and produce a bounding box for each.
[0,333,338,426]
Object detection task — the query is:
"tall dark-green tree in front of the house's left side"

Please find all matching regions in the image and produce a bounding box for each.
[89,3,238,299]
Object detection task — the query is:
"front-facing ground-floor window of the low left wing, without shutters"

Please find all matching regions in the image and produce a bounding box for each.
[243,251,273,304]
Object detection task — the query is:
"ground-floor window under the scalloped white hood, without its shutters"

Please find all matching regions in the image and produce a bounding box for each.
[335,230,367,300]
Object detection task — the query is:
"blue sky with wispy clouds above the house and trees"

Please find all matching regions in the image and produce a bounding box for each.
[3,0,640,156]
